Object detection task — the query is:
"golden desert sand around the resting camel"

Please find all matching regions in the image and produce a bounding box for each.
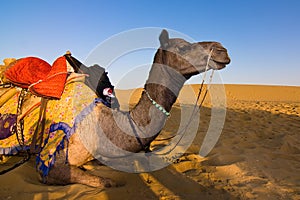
[0,85,300,200]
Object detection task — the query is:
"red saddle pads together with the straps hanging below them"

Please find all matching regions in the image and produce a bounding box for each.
[2,56,68,153]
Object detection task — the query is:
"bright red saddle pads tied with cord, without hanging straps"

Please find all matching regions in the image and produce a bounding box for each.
[4,56,67,99]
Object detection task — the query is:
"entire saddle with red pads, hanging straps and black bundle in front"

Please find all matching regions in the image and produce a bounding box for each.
[0,52,120,153]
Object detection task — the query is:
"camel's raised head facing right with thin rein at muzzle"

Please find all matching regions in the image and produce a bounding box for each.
[154,30,230,79]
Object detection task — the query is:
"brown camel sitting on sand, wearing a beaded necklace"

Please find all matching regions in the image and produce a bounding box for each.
[40,30,230,188]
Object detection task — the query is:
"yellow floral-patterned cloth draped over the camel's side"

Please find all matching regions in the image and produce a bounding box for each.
[0,76,96,155]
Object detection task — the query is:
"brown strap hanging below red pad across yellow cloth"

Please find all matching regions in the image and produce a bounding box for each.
[30,98,48,153]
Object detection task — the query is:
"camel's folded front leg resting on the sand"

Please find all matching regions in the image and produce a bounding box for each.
[38,153,116,188]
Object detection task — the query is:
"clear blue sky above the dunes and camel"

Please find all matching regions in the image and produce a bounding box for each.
[0,0,300,87]
